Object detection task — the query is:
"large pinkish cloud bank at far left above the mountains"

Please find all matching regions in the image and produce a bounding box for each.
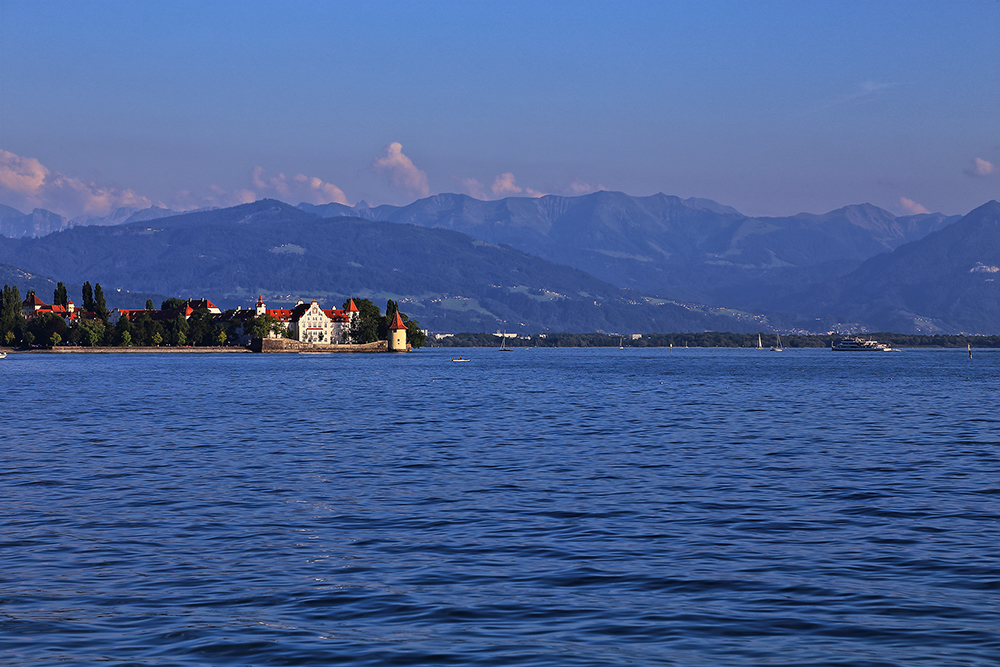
[0,149,152,218]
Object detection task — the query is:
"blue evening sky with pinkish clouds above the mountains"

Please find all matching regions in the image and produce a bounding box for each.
[0,0,1000,215]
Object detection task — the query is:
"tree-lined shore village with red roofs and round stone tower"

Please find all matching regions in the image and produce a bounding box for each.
[0,282,426,352]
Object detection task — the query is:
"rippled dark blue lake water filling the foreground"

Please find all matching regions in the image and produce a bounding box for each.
[0,349,1000,666]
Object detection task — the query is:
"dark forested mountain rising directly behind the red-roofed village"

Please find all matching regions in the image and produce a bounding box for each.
[0,200,766,332]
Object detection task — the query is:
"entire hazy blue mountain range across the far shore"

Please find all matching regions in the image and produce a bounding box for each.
[0,192,1000,333]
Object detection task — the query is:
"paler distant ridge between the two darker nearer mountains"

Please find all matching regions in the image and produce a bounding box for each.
[299,191,958,309]
